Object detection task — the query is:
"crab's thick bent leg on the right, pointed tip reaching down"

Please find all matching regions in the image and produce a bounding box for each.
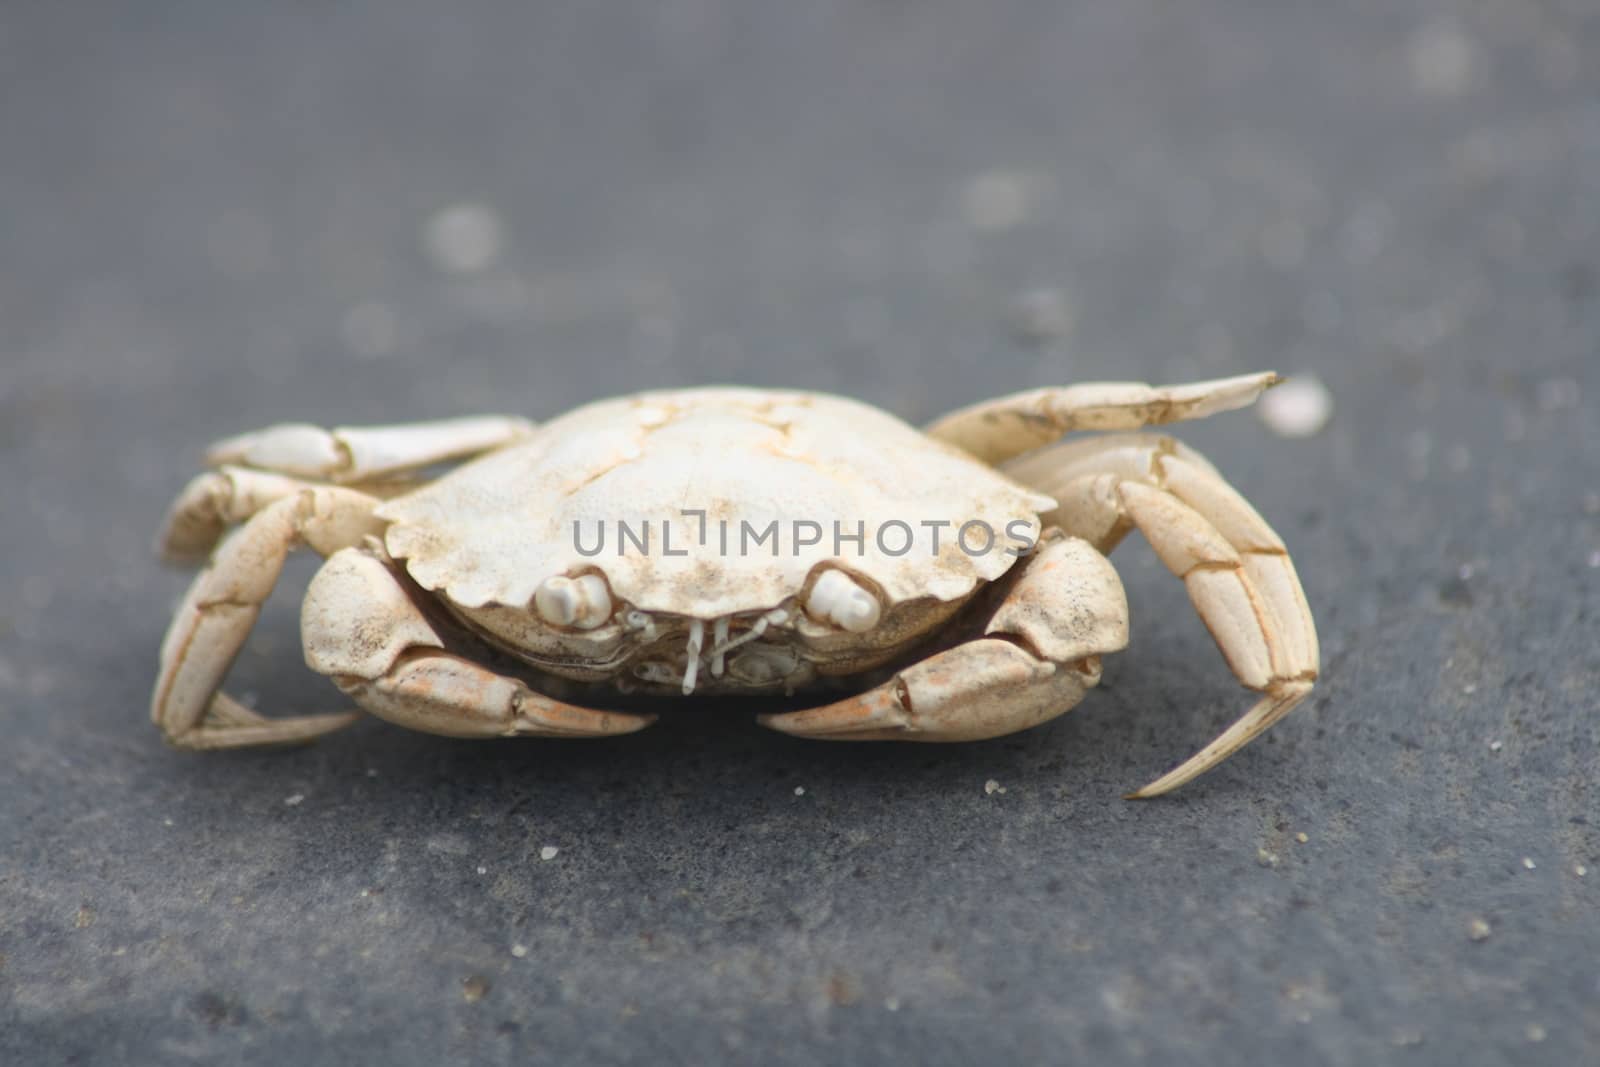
[1003,434,1318,798]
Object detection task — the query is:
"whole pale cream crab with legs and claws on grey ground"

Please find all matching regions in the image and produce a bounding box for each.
[152,373,1318,797]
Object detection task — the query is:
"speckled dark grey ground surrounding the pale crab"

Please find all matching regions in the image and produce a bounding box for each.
[0,0,1600,1067]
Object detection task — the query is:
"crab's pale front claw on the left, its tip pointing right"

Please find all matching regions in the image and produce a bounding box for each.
[301,549,654,737]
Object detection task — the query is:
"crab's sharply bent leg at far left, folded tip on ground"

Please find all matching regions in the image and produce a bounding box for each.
[150,486,382,749]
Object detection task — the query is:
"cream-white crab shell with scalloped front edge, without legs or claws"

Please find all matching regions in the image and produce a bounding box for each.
[376,387,1054,688]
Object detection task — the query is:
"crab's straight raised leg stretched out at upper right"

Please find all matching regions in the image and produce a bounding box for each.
[923,371,1283,464]
